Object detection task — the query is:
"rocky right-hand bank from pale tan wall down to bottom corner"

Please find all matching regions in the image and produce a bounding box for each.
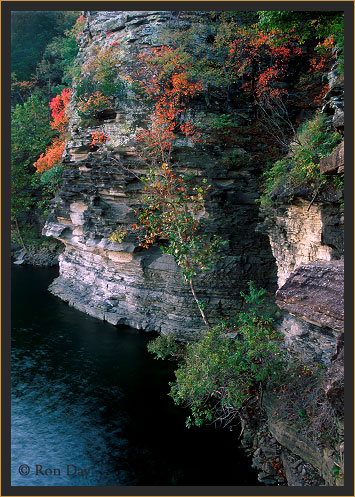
[254,136,344,486]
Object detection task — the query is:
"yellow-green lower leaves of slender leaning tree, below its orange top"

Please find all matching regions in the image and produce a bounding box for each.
[138,164,223,282]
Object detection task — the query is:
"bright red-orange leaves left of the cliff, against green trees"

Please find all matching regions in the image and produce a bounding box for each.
[33,88,73,173]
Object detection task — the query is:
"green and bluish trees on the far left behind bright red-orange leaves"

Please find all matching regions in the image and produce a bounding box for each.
[11,11,78,245]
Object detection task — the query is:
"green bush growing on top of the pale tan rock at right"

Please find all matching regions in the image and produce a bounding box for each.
[261,113,341,205]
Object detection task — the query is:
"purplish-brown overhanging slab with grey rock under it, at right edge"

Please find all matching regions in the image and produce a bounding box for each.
[276,260,344,365]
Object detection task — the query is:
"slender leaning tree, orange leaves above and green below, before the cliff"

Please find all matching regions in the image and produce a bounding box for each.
[132,47,222,328]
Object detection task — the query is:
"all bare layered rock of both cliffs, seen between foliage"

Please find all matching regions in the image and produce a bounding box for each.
[44,12,344,485]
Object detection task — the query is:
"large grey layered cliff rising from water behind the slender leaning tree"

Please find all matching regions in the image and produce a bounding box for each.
[44,12,275,336]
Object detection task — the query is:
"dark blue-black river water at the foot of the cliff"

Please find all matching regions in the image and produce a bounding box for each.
[11,267,258,486]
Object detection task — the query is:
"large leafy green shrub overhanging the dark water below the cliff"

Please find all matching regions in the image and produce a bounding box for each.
[165,284,284,426]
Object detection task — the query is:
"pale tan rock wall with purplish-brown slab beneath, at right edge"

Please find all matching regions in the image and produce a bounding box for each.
[258,181,344,364]
